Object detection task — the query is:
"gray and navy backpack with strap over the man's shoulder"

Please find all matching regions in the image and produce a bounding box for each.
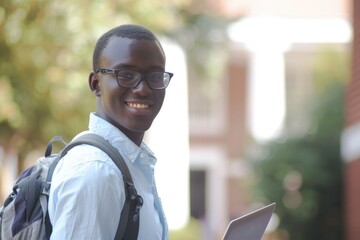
[0,133,143,240]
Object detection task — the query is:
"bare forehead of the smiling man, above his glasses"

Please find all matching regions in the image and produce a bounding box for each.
[100,37,165,68]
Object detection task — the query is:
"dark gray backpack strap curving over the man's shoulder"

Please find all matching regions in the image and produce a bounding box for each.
[47,133,143,240]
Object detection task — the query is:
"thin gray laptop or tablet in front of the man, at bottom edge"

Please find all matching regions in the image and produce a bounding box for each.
[223,203,276,240]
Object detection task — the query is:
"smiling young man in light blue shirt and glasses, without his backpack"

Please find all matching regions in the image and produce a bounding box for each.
[49,25,173,240]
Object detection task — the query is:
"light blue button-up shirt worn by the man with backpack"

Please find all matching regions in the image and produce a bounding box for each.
[48,113,168,240]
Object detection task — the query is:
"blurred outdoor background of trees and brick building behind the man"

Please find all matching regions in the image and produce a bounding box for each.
[0,0,360,240]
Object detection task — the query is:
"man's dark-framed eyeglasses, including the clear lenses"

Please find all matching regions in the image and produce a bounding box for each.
[96,68,174,89]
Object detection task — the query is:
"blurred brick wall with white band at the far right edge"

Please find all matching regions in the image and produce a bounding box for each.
[342,0,360,240]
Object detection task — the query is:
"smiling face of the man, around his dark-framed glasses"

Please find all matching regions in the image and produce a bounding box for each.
[92,37,165,141]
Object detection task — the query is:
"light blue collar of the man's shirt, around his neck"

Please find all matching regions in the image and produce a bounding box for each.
[89,113,156,165]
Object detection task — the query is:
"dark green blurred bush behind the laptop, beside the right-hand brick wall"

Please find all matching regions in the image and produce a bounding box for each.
[250,48,344,240]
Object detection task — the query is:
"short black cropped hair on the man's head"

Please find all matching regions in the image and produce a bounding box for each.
[93,24,162,71]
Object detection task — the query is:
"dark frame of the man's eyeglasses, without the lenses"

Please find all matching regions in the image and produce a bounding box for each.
[96,68,174,90]
